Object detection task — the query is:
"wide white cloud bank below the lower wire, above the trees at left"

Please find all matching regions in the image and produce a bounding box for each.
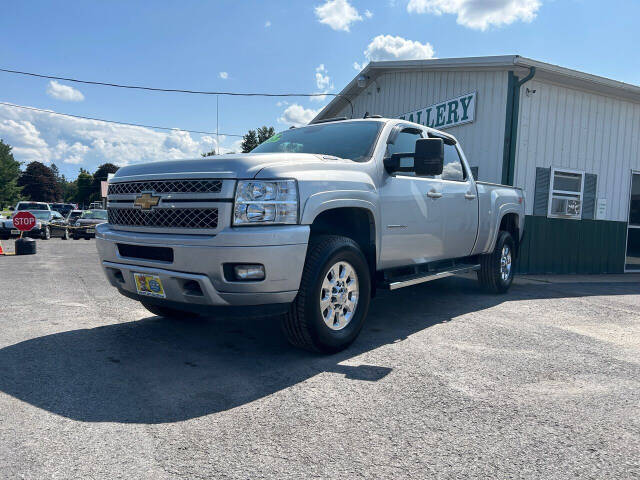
[0,105,237,178]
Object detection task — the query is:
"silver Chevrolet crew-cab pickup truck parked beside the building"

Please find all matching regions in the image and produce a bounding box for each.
[96,117,524,352]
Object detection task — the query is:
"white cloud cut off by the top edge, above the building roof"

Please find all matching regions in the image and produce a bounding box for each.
[407,0,541,30]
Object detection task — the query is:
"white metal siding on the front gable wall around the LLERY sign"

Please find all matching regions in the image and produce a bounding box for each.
[338,71,508,182]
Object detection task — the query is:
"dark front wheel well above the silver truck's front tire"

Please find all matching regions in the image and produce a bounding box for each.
[311,207,376,295]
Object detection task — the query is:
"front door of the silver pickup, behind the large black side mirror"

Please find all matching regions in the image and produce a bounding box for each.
[380,127,446,268]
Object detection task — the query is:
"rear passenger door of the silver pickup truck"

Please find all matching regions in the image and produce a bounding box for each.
[438,143,478,258]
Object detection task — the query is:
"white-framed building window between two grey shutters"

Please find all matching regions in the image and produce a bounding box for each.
[547,168,584,220]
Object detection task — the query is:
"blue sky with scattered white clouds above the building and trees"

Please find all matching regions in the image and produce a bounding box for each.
[0,0,640,178]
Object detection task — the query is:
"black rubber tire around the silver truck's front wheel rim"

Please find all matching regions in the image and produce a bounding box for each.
[282,235,371,353]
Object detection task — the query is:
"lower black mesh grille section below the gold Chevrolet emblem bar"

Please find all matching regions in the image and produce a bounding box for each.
[107,207,218,229]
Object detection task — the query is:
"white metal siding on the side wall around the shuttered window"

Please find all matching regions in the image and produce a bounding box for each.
[515,78,640,222]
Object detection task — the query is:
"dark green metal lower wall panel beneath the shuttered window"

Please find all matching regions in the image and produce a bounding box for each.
[516,215,627,274]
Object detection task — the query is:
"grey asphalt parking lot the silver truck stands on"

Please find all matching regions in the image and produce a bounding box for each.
[0,239,640,479]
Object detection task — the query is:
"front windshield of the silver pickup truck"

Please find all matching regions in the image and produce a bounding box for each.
[252,122,383,162]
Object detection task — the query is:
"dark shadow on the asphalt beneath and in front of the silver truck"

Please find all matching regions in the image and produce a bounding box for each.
[0,278,637,423]
